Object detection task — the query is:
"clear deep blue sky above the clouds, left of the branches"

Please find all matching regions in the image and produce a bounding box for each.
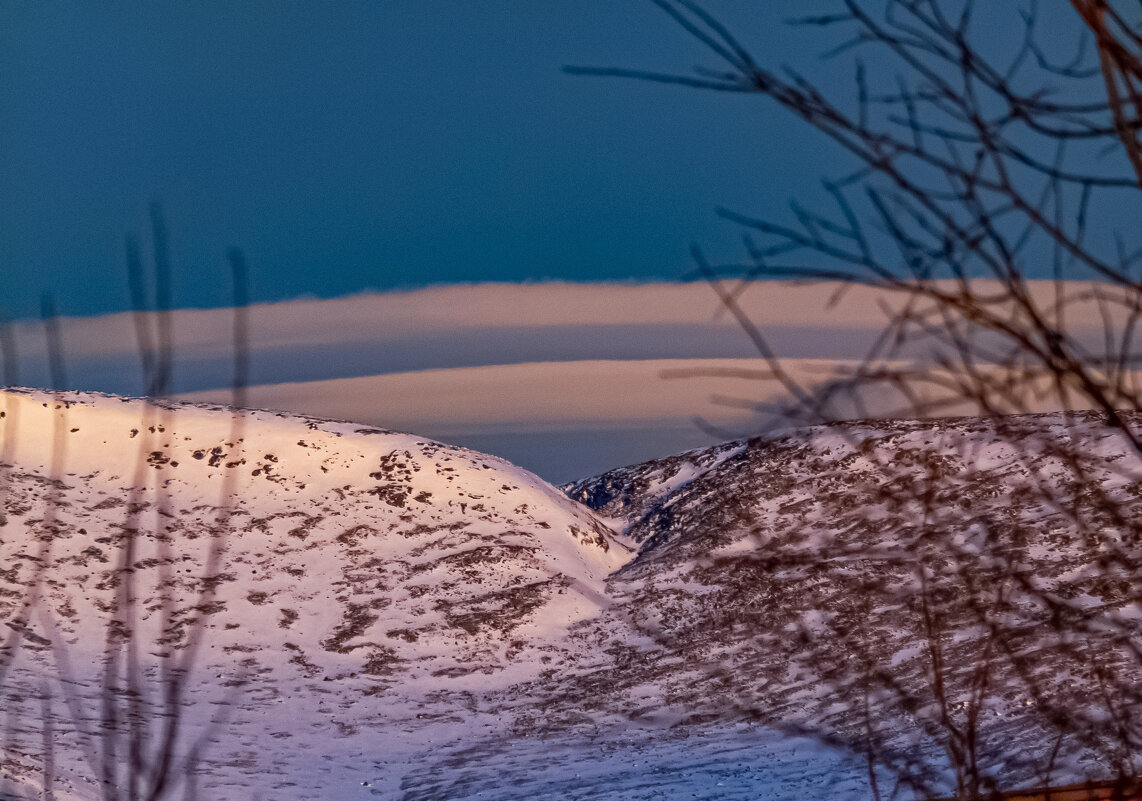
[0,0,838,318]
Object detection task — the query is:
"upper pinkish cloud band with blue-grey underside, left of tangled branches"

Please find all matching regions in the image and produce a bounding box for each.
[6,282,927,393]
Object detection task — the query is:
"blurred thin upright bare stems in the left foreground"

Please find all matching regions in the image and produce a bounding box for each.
[0,205,248,801]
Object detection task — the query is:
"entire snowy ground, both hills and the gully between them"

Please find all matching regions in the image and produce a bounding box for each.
[0,391,1142,801]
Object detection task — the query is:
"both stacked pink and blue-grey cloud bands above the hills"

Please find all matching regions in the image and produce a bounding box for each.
[13,282,1132,480]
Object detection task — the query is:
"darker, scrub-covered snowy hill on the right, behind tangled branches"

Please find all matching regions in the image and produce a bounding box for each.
[561,412,1142,788]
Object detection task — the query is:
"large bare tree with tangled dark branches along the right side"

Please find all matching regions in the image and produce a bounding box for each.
[568,0,1142,799]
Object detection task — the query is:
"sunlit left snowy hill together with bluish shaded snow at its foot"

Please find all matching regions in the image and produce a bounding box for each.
[0,390,860,801]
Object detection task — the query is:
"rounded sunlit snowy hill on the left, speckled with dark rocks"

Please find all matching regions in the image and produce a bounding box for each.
[0,391,630,798]
